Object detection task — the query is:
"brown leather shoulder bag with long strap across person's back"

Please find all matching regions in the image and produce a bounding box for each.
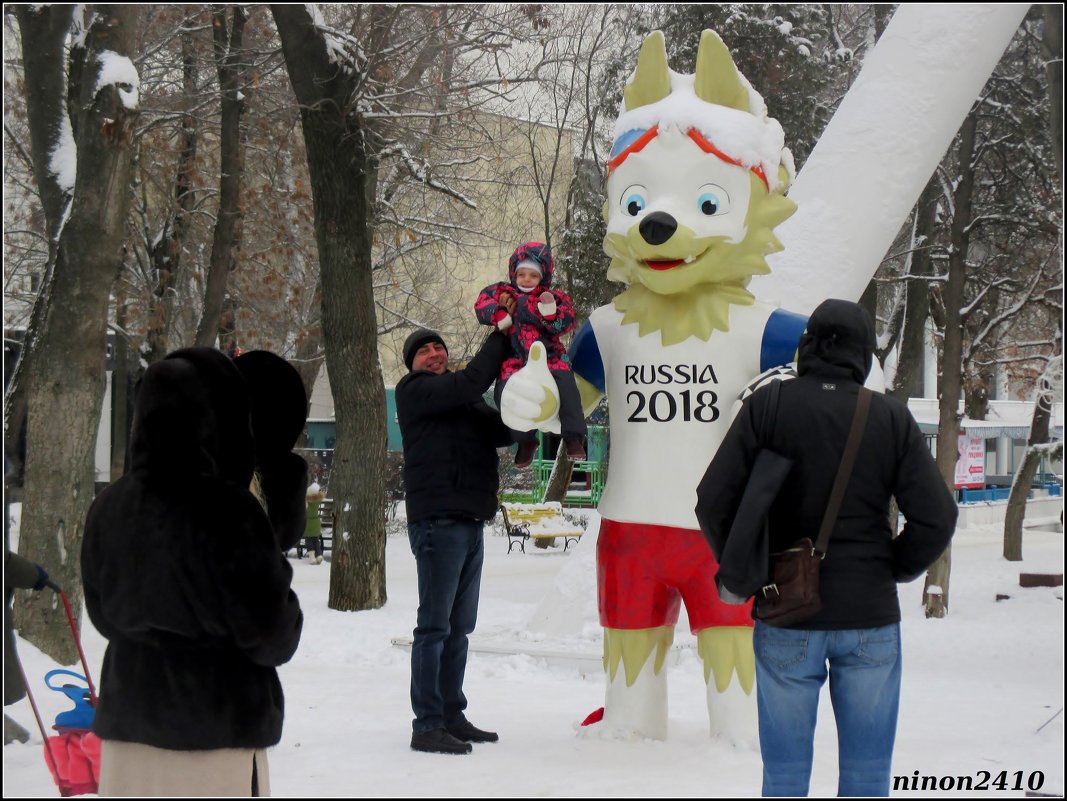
[752,387,871,626]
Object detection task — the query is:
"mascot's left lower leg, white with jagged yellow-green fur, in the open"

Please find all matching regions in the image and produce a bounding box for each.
[602,626,674,740]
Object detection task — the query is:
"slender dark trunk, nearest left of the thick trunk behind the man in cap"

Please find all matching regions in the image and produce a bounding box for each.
[196,5,249,348]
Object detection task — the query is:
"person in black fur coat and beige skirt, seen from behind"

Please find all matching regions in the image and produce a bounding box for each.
[81,348,307,796]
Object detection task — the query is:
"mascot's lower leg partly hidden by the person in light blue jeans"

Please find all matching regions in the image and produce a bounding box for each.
[697,626,760,751]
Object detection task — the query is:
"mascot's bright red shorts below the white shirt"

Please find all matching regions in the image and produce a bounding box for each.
[596,519,752,634]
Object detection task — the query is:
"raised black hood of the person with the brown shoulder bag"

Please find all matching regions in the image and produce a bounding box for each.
[797,300,875,384]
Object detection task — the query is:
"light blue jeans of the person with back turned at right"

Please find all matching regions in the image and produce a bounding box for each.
[752,621,901,796]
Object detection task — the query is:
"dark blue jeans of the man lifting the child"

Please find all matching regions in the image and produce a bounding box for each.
[408,517,483,734]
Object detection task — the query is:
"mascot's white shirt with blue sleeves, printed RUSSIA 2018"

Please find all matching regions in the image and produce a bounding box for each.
[572,303,803,529]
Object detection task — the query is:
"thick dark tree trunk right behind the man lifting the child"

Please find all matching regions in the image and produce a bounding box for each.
[271,5,386,611]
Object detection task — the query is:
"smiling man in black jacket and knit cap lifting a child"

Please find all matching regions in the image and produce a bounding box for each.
[396,329,510,754]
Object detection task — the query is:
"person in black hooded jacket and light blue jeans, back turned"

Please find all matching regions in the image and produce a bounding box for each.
[701,300,957,796]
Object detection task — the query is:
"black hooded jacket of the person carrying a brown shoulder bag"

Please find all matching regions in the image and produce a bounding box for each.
[699,301,958,629]
